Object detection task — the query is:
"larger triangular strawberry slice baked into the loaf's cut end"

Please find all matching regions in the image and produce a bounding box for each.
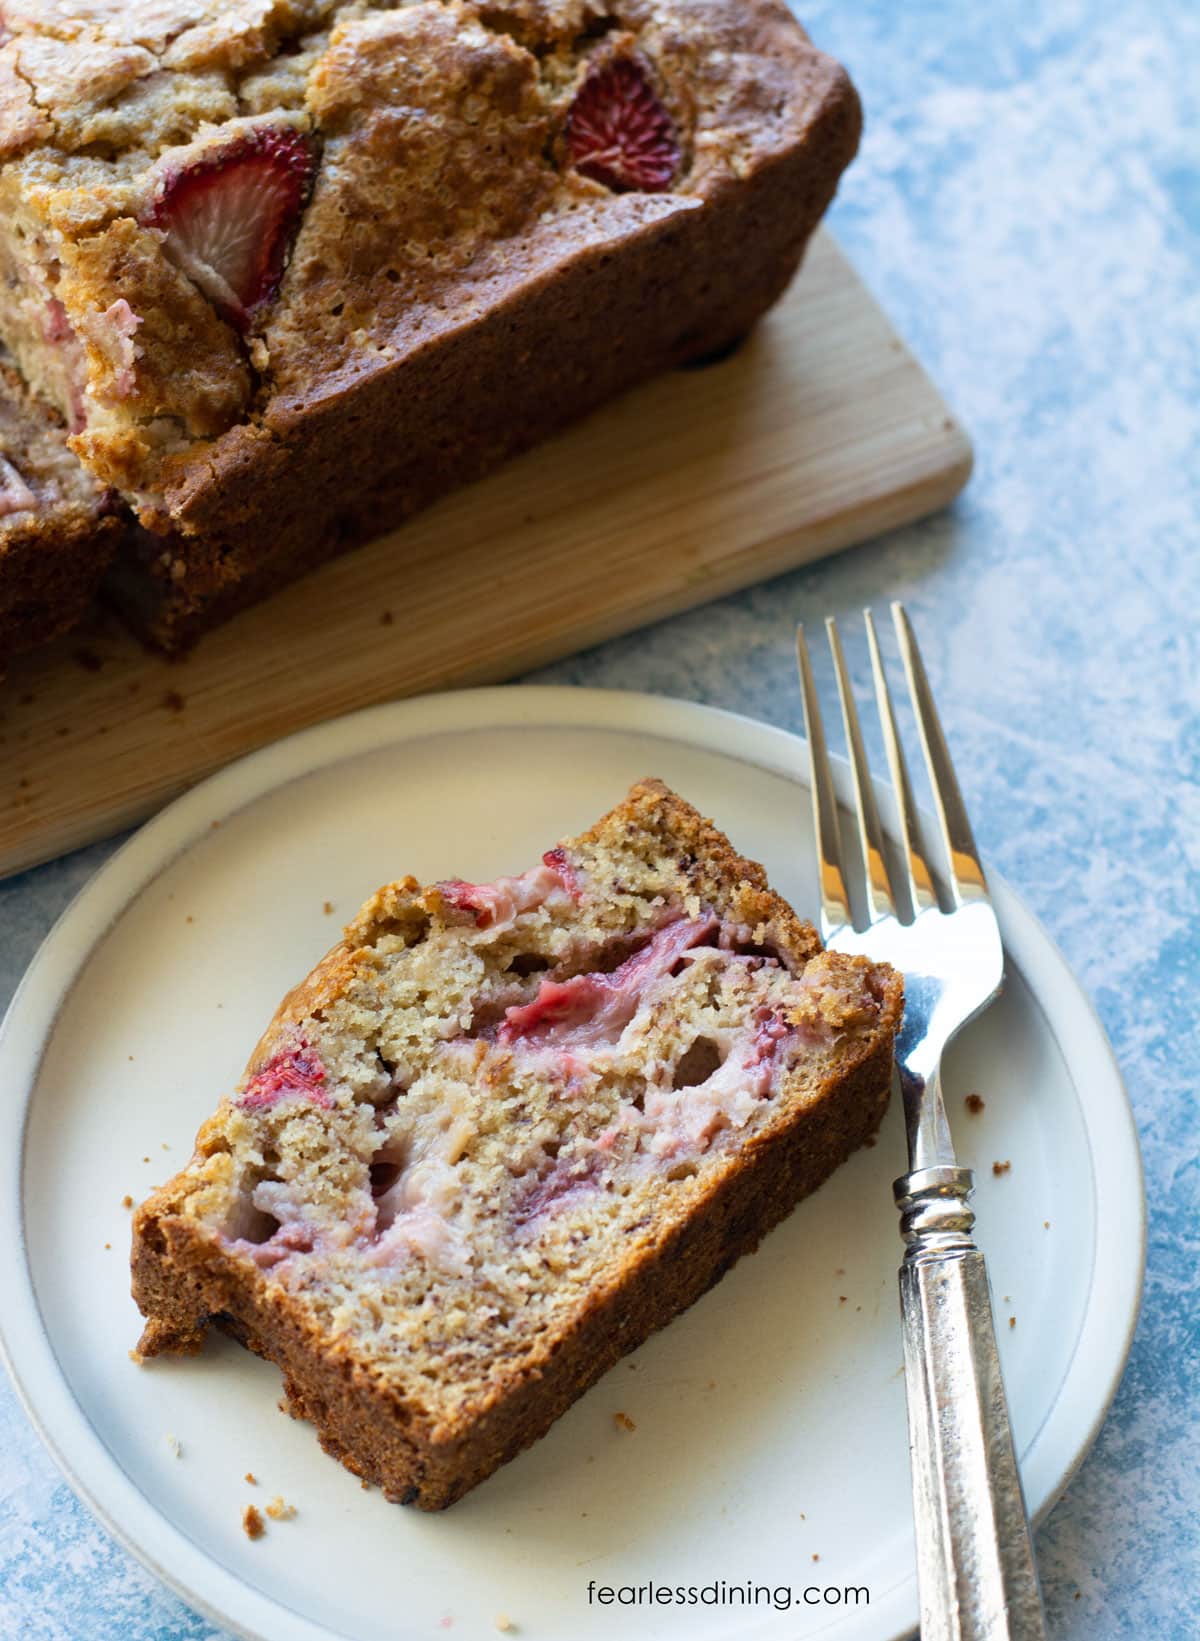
[143,130,314,330]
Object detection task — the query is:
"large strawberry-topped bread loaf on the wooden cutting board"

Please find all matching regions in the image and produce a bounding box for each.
[0,0,860,647]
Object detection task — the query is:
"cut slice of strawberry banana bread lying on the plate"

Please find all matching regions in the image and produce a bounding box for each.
[133,781,901,1510]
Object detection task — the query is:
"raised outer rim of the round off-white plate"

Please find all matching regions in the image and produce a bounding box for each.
[0,684,1146,1641]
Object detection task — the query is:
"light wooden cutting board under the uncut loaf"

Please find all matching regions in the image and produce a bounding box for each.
[0,233,970,875]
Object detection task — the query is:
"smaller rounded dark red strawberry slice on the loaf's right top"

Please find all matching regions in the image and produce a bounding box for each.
[566,57,680,194]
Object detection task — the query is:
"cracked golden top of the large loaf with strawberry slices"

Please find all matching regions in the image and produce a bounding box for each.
[0,0,857,528]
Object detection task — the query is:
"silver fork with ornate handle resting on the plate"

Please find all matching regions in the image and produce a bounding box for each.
[796,604,1046,1641]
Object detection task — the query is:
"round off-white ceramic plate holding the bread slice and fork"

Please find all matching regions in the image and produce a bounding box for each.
[0,689,1144,1641]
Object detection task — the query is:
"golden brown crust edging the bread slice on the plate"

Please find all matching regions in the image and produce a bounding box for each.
[133,779,903,1510]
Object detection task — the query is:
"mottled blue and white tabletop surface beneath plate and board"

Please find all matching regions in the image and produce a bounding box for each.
[0,0,1200,1641]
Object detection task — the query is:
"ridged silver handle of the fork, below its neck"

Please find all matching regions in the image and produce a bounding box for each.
[895,1168,1046,1641]
